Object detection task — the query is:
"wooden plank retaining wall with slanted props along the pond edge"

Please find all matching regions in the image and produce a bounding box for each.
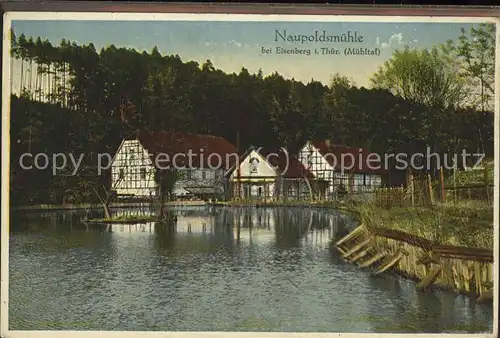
[336,225,493,302]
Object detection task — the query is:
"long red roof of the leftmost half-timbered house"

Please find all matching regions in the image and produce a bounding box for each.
[133,130,237,170]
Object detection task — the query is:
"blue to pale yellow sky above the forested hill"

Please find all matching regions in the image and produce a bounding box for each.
[8,21,480,88]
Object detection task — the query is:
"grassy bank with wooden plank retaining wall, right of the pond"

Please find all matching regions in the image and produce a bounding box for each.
[335,201,494,302]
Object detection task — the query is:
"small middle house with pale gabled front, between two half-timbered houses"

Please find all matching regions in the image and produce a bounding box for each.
[226,147,326,200]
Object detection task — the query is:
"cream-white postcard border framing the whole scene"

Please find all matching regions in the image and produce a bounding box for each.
[0,7,500,337]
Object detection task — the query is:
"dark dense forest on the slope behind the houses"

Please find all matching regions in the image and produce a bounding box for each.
[11,23,493,203]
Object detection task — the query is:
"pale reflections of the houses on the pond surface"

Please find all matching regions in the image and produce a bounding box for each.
[110,207,346,250]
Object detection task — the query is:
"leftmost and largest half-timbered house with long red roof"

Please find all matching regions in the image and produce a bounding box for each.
[111,131,237,198]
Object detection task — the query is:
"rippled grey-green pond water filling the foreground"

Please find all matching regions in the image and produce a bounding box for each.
[9,207,493,333]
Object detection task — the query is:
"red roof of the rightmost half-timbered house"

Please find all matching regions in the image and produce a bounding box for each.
[311,141,387,174]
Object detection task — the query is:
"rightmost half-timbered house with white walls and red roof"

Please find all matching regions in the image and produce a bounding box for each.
[298,141,387,194]
